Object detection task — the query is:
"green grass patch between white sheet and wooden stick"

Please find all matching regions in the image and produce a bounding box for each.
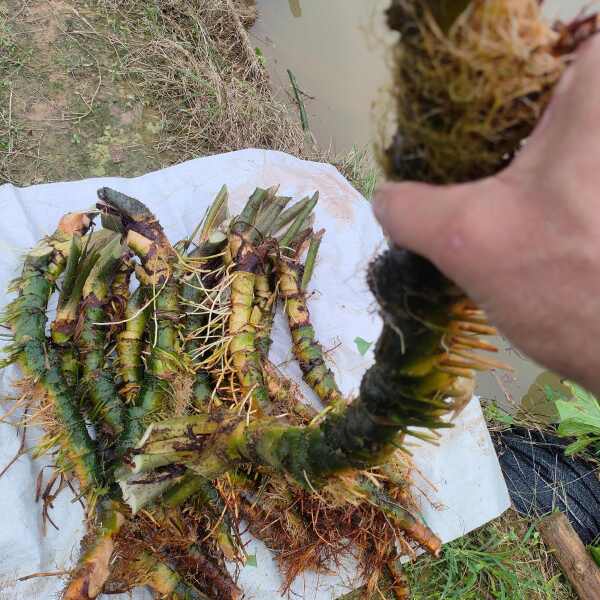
[406,511,576,600]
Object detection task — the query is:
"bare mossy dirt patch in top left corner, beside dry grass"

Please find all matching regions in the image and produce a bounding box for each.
[0,0,162,185]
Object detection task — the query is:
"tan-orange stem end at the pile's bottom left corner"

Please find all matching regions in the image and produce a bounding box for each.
[63,501,128,600]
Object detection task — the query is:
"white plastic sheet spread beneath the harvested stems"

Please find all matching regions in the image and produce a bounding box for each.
[0,150,509,600]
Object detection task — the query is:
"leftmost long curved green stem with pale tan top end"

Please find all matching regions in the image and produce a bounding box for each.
[6,213,101,489]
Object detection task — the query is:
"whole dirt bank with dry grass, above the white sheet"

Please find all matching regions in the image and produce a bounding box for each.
[0,0,302,185]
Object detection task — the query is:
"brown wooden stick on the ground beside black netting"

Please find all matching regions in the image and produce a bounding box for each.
[538,513,600,600]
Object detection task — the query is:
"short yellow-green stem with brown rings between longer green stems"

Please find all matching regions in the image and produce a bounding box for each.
[116,286,149,403]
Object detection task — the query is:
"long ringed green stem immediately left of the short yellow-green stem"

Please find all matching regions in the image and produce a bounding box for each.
[77,238,125,435]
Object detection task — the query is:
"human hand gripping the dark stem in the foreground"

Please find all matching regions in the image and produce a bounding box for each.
[374,36,600,392]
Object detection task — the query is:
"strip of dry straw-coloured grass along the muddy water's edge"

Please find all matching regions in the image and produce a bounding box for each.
[98,0,304,160]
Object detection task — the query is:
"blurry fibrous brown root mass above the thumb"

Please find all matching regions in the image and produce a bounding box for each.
[385,0,569,183]
